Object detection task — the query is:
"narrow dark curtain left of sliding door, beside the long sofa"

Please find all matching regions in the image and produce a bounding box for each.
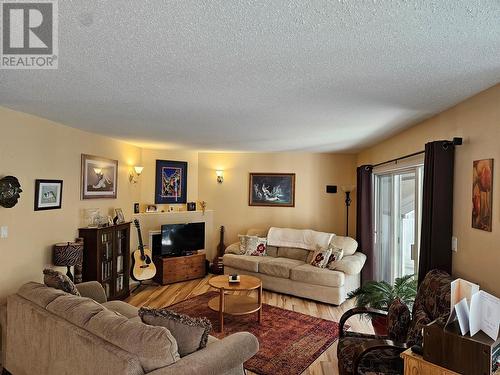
[356,165,376,283]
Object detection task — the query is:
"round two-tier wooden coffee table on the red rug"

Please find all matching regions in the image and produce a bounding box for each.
[208,275,262,332]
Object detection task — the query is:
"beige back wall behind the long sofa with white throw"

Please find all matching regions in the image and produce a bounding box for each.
[198,153,356,245]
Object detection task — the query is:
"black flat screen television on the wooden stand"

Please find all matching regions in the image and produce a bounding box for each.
[161,223,205,256]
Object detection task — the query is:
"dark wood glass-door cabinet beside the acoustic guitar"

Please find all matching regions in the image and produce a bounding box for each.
[79,222,130,300]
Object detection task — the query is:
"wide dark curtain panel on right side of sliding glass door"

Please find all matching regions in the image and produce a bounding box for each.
[418,141,455,285]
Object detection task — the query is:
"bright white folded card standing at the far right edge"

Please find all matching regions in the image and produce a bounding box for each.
[468,290,500,340]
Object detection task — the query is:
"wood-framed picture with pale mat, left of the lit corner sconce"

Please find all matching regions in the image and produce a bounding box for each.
[82,154,118,199]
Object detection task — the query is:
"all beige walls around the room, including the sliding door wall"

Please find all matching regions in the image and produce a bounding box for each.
[0,85,500,300]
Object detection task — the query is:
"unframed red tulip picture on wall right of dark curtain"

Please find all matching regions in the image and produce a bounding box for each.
[472,159,493,232]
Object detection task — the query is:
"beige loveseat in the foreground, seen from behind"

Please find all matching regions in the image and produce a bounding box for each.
[2,282,258,375]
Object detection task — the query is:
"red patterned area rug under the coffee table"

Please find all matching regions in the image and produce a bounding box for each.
[169,292,339,375]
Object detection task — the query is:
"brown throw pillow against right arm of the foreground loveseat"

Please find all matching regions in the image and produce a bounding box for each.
[139,307,212,357]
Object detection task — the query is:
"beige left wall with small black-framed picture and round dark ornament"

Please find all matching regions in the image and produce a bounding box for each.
[0,107,141,300]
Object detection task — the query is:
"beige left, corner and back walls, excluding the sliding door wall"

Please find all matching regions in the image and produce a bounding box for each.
[0,107,356,300]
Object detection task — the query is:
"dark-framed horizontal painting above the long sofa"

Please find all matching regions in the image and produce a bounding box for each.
[248,173,295,207]
